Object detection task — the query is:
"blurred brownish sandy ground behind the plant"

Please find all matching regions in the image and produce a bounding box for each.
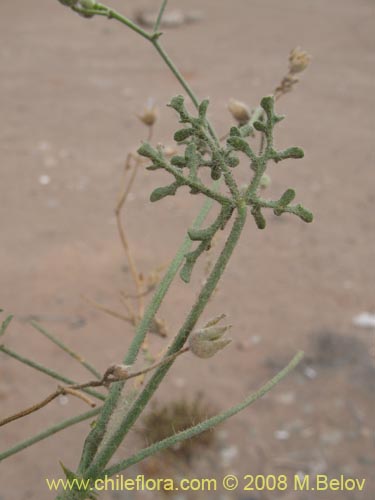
[0,0,375,500]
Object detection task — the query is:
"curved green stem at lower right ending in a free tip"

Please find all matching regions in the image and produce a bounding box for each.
[103,351,304,477]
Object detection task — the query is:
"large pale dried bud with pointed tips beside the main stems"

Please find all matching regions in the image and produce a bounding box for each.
[189,315,232,358]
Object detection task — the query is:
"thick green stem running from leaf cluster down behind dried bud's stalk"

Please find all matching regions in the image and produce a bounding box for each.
[85,204,247,478]
